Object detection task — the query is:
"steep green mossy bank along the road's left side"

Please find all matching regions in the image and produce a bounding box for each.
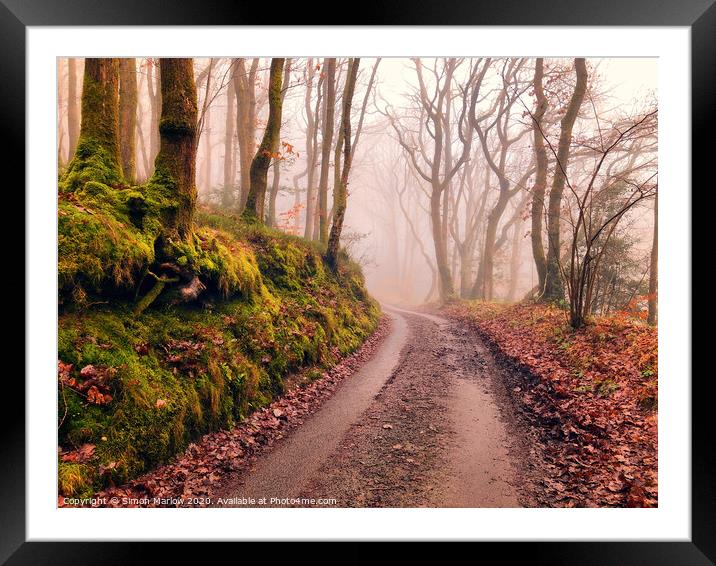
[58,207,380,496]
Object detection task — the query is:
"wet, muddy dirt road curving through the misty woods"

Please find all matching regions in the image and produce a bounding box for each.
[214,307,532,507]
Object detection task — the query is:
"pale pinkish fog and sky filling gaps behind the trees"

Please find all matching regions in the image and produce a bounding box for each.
[58,58,657,313]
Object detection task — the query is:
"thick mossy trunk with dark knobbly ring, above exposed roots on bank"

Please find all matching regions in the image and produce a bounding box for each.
[154,59,198,241]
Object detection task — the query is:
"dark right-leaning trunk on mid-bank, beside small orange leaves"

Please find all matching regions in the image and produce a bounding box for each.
[242,58,286,223]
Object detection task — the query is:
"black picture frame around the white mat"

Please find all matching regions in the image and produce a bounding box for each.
[0,0,716,565]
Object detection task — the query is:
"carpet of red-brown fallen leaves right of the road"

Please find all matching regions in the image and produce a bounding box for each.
[446,303,658,507]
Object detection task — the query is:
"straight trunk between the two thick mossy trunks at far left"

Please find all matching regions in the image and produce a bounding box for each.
[119,58,137,185]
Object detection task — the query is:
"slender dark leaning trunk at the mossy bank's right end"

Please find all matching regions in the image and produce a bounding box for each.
[326,58,360,269]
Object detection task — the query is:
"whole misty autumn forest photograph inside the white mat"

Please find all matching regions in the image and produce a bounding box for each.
[57,57,658,507]
